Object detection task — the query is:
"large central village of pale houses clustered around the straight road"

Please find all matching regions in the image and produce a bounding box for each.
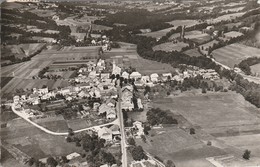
[7,52,219,167]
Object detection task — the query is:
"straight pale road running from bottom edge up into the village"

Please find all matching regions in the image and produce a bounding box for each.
[116,86,127,167]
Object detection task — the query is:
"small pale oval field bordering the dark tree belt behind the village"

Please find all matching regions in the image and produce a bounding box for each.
[153,42,189,52]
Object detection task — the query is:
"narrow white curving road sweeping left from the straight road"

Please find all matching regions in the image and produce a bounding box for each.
[11,104,119,136]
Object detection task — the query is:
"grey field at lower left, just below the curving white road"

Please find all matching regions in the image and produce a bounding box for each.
[1,119,82,159]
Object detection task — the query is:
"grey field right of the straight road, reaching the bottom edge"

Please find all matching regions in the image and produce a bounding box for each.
[136,127,225,167]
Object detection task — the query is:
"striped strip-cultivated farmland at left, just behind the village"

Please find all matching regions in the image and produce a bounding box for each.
[1,47,99,99]
